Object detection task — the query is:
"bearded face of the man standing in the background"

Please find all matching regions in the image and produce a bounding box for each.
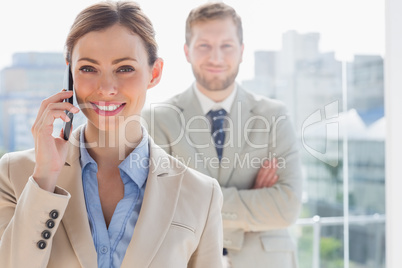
[184,18,243,91]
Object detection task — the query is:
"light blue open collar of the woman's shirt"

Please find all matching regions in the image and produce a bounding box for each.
[80,126,149,188]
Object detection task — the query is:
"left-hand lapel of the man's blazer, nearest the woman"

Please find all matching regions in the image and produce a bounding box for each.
[176,87,219,178]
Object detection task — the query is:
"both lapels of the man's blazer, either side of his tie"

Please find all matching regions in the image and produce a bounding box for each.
[175,85,256,186]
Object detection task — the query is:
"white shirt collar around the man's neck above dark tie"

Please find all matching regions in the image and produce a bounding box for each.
[193,83,237,115]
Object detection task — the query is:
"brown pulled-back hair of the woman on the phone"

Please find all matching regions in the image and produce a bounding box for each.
[65,1,158,65]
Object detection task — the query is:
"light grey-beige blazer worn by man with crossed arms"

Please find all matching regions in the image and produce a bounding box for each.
[143,86,302,268]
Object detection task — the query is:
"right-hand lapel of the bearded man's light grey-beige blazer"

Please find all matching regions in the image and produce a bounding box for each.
[219,85,255,187]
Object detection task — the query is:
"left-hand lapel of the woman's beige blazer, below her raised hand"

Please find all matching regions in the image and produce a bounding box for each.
[58,128,97,268]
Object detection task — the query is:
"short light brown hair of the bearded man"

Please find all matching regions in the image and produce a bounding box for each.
[186,3,243,45]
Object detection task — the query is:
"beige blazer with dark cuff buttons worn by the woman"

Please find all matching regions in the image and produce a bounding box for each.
[0,126,222,268]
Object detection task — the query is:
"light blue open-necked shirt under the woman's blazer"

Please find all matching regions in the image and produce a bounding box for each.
[80,128,149,268]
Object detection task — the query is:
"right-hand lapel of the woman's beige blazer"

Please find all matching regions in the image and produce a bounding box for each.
[121,138,183,268]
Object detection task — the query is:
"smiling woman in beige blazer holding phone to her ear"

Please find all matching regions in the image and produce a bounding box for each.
[0,2,222,268]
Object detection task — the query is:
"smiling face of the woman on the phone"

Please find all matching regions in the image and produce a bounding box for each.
[71,24,163,130]
